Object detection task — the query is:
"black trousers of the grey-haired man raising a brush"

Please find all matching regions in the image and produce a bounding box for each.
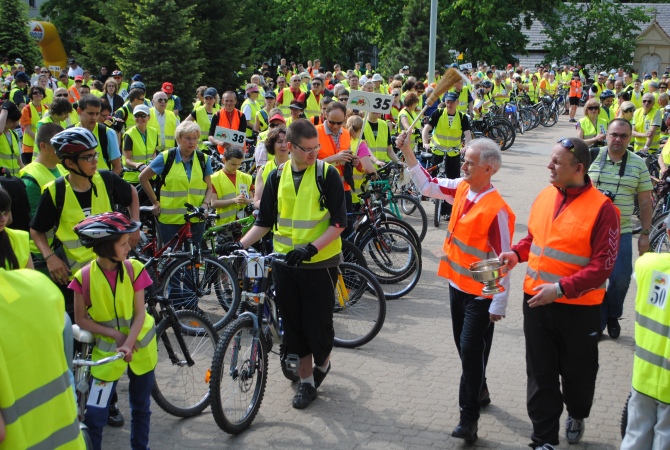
[449,285,494,422]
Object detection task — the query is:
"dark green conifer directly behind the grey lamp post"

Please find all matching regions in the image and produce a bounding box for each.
[380,0,451,79]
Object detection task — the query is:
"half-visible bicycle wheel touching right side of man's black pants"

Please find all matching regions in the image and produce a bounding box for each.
[333,263,386,348]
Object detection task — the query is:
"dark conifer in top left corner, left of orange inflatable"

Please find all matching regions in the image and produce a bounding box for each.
[0,0,42,67]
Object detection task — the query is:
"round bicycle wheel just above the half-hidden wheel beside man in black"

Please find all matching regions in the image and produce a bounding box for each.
[361,229,422,300]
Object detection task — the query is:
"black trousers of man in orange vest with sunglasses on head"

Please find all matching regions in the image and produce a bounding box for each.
[523,294,600,445]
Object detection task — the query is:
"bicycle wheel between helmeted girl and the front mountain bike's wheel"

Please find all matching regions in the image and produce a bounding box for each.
[151,310,218,417]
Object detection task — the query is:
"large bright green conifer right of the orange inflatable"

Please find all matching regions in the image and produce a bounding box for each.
[117,0,205,110]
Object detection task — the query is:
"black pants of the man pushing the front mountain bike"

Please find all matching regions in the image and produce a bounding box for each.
[273,264,337,366]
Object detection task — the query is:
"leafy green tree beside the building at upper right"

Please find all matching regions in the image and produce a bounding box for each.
[544,0,649,70]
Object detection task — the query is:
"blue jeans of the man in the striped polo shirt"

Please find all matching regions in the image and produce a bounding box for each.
[600,233,633,330]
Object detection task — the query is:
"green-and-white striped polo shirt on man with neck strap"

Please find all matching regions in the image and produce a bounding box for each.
[589,148,652,234]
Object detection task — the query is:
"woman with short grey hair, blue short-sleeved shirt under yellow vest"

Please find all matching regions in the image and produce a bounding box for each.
[140,122,212,245]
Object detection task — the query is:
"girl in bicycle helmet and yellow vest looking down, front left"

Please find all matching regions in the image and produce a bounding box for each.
[69,212,158,450]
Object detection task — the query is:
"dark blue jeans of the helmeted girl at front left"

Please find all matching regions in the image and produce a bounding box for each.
[84,366,155,450]
